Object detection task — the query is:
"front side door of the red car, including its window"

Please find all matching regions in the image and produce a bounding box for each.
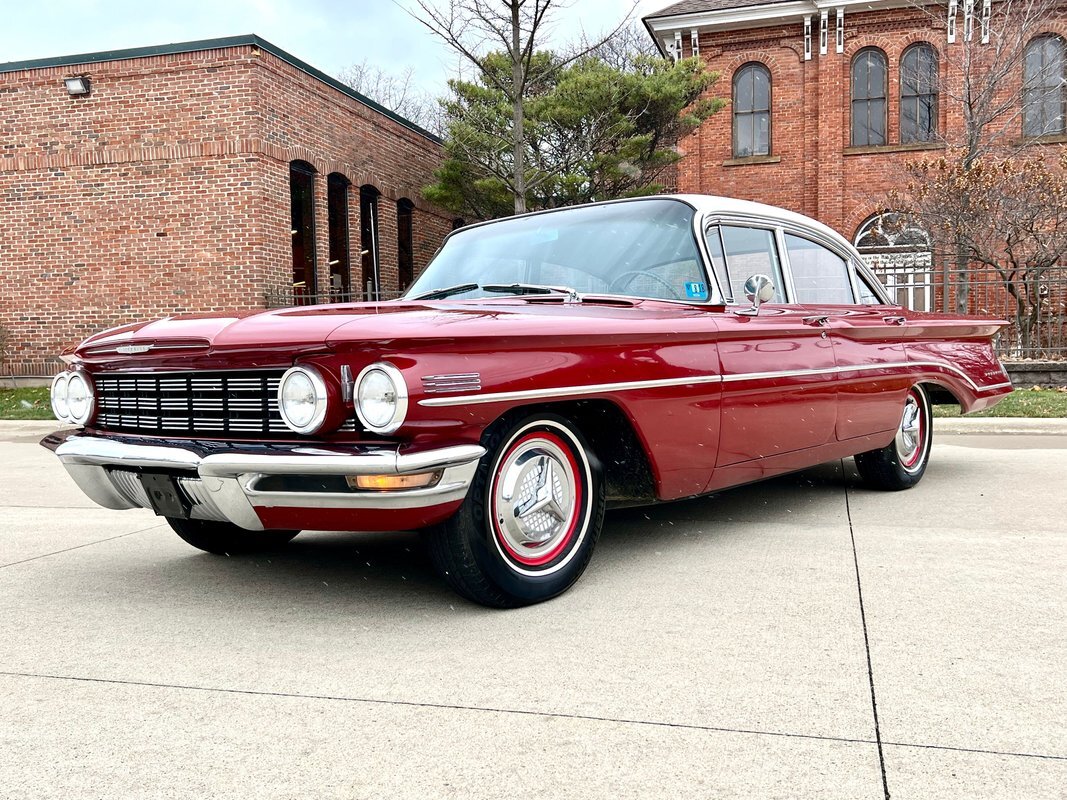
[705,221,837,466]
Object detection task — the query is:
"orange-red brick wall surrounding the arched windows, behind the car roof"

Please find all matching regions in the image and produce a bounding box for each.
[678,4,1067,239]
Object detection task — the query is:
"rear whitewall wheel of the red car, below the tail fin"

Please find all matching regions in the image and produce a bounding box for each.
[856,385,934,491]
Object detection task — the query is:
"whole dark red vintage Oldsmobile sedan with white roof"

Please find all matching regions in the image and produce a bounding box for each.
[43,195,1010,607]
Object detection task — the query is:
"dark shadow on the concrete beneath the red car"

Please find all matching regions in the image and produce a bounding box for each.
[98,463,856,613]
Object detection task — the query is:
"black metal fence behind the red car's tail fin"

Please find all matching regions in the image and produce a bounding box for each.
[870,253,1067,361]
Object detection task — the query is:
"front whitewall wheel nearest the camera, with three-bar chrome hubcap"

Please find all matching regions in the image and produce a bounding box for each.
[428,414,605,608]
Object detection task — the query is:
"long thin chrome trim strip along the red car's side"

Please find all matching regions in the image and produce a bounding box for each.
[418,362,1012,407]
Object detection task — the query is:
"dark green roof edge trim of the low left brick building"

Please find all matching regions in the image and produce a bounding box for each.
[0,33,441,144]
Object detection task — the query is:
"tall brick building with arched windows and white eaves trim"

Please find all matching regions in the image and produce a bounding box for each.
[644,0,1067,320]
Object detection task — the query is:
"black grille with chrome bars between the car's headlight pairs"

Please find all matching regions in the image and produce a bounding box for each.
[95,370,288,438]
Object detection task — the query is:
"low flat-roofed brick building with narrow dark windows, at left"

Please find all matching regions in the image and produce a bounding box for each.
[0,35,452,374]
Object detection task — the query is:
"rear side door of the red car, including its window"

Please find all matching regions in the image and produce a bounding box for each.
[782,230,909,441]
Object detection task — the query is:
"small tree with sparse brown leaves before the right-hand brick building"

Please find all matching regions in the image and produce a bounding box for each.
[888,0,1067,320]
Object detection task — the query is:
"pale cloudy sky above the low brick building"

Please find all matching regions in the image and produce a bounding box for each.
[0,0,671,99]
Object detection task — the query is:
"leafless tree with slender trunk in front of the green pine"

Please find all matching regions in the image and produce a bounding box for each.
[407,0,636,213]
